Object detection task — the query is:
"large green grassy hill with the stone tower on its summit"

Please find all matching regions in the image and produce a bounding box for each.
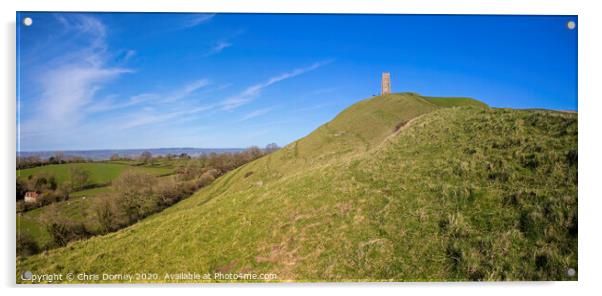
[17,94,578,281]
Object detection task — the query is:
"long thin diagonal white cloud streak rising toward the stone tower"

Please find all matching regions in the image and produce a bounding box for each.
[221,60,332,110]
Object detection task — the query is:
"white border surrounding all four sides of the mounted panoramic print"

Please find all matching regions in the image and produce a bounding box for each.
[0,0,602,296]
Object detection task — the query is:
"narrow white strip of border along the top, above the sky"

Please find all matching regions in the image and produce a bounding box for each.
[1,0,581,14]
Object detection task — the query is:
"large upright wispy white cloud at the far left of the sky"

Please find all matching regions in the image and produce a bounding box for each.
[21,15,133,139]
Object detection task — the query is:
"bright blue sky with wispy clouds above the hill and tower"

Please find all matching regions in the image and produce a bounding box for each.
[17,12,577,151]
